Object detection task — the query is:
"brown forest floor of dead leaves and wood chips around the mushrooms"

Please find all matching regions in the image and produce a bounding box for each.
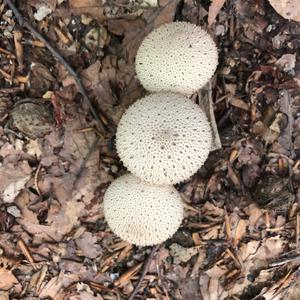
[0,0,300,300]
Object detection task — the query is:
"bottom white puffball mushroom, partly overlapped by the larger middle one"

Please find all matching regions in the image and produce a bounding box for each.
[103,174,183,246]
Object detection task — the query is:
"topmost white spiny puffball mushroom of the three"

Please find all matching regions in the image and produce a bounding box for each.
[135,22,218,95]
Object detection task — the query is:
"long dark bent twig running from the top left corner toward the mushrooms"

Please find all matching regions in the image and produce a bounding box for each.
[4,0,106,130]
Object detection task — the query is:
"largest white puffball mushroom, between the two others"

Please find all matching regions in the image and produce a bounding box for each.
[116,93,212,184]
